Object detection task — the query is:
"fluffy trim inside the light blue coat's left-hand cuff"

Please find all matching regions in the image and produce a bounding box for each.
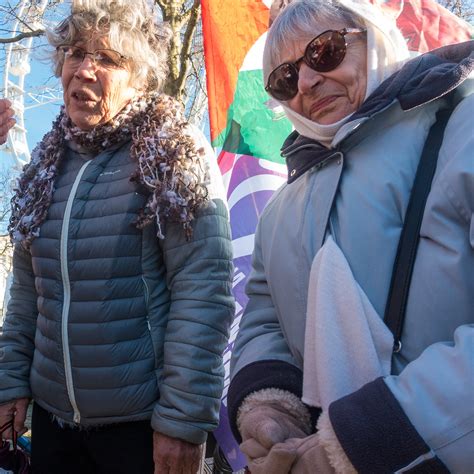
[237,388,311,433]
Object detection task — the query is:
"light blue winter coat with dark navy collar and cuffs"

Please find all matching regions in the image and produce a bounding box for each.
[228,41,474,474]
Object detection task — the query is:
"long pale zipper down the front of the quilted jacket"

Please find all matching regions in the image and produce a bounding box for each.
[60,160,92,423]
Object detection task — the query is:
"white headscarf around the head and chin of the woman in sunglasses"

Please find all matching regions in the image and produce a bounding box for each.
[270,0,409,148]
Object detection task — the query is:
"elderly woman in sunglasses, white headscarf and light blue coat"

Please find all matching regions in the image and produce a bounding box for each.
[228,0,474,474]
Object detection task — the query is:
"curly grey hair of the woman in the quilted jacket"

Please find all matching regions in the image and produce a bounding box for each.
[47,0,170,92]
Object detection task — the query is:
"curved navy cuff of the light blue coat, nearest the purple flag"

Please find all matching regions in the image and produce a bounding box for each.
[227,360,321,443]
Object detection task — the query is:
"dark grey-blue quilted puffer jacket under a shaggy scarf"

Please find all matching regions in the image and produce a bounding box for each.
[0,127,234,443]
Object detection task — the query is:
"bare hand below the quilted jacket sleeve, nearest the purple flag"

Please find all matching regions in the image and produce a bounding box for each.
[153,431,201,474]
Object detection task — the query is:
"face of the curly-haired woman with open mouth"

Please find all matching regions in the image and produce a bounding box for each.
[61,38,137,130]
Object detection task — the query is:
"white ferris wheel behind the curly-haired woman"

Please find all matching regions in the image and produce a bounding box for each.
[2,0,62,171]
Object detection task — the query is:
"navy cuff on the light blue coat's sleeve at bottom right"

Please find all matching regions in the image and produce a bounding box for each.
[329,378,449,474]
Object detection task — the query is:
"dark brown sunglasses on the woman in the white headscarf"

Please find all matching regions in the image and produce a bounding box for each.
[265,28,366,101]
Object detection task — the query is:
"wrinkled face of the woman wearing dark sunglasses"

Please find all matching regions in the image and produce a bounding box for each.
[283,23,367,125]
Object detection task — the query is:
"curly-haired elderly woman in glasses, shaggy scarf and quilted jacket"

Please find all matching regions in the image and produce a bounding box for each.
[0,0,234,474]
